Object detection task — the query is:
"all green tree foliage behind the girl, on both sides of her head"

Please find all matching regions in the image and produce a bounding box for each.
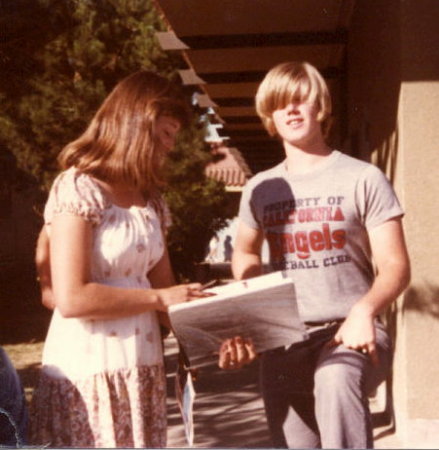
[0,0,232,278]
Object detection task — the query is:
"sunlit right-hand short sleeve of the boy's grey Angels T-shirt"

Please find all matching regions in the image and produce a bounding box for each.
[357,164,404,229]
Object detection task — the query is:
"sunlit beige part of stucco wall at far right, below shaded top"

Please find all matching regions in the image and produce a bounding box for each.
[400,81,439,443]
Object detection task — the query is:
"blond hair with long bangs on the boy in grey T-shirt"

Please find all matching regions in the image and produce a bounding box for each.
[256,62,332,136]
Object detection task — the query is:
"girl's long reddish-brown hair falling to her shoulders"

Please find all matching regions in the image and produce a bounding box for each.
[58,71,189,193]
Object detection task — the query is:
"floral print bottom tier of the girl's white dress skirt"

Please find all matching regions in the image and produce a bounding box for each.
[31,365,166,448]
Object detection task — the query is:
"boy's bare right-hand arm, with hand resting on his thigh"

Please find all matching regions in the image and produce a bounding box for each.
[334,219,410,363]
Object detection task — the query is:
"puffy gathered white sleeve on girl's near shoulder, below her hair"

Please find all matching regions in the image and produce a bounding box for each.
[44,168,106,225]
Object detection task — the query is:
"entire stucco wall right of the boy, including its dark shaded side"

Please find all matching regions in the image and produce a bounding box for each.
[347,0,439,448]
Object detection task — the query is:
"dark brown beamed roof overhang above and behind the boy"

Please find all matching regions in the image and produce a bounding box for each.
[155,0,355,173]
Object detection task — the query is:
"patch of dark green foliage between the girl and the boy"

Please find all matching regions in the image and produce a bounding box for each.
[165,121,231,279]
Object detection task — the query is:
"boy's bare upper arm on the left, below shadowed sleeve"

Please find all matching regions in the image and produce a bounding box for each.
[232,221,264,280]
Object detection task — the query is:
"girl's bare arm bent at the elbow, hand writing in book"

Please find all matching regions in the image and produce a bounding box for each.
[50,215,199,319]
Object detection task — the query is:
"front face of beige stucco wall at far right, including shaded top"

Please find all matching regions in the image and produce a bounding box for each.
[400,0,439,436]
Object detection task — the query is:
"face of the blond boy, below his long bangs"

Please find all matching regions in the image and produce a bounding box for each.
[272,100,322,146]
